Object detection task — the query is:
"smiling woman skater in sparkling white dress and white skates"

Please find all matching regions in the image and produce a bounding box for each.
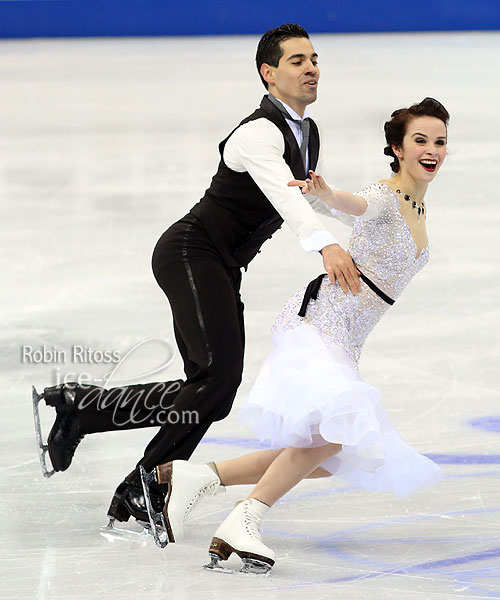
[141,98,449,572]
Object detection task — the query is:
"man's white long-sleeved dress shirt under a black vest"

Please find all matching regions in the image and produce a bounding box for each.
[223,97,338,252]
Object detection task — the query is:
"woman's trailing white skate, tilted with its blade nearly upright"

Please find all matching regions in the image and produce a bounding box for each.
[143,460,225,548]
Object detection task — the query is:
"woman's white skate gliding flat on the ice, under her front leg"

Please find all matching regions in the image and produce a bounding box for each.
[205,498,275,575]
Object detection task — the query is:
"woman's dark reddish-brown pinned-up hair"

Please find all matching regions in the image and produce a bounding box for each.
[384,98,450,173]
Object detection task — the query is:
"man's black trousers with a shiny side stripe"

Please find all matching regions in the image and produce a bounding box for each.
[76,215,245,470]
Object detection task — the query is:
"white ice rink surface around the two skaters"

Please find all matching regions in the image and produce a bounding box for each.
[0,33,500,600]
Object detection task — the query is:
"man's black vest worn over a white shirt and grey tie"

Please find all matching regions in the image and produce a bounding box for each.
[190,96,319,268]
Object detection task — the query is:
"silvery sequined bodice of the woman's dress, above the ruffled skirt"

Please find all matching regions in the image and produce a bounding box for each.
[273,183,429,365]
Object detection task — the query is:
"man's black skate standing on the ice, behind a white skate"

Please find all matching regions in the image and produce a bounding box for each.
[102,469,166,535]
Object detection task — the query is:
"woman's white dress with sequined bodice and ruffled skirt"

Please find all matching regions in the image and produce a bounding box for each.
[238,183,442,496]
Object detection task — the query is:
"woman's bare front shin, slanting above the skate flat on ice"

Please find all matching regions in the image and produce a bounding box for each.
[248,444,342,506]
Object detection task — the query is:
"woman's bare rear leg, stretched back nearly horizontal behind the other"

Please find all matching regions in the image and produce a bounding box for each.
[217,448,331,486]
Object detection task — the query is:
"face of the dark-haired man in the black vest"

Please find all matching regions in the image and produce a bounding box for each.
[261,38,319,116]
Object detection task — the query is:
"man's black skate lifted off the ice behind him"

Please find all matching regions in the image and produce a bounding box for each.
[33,383,84,477]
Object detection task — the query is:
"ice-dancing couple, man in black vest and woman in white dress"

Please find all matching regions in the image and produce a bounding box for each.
[34,25,448,570]
